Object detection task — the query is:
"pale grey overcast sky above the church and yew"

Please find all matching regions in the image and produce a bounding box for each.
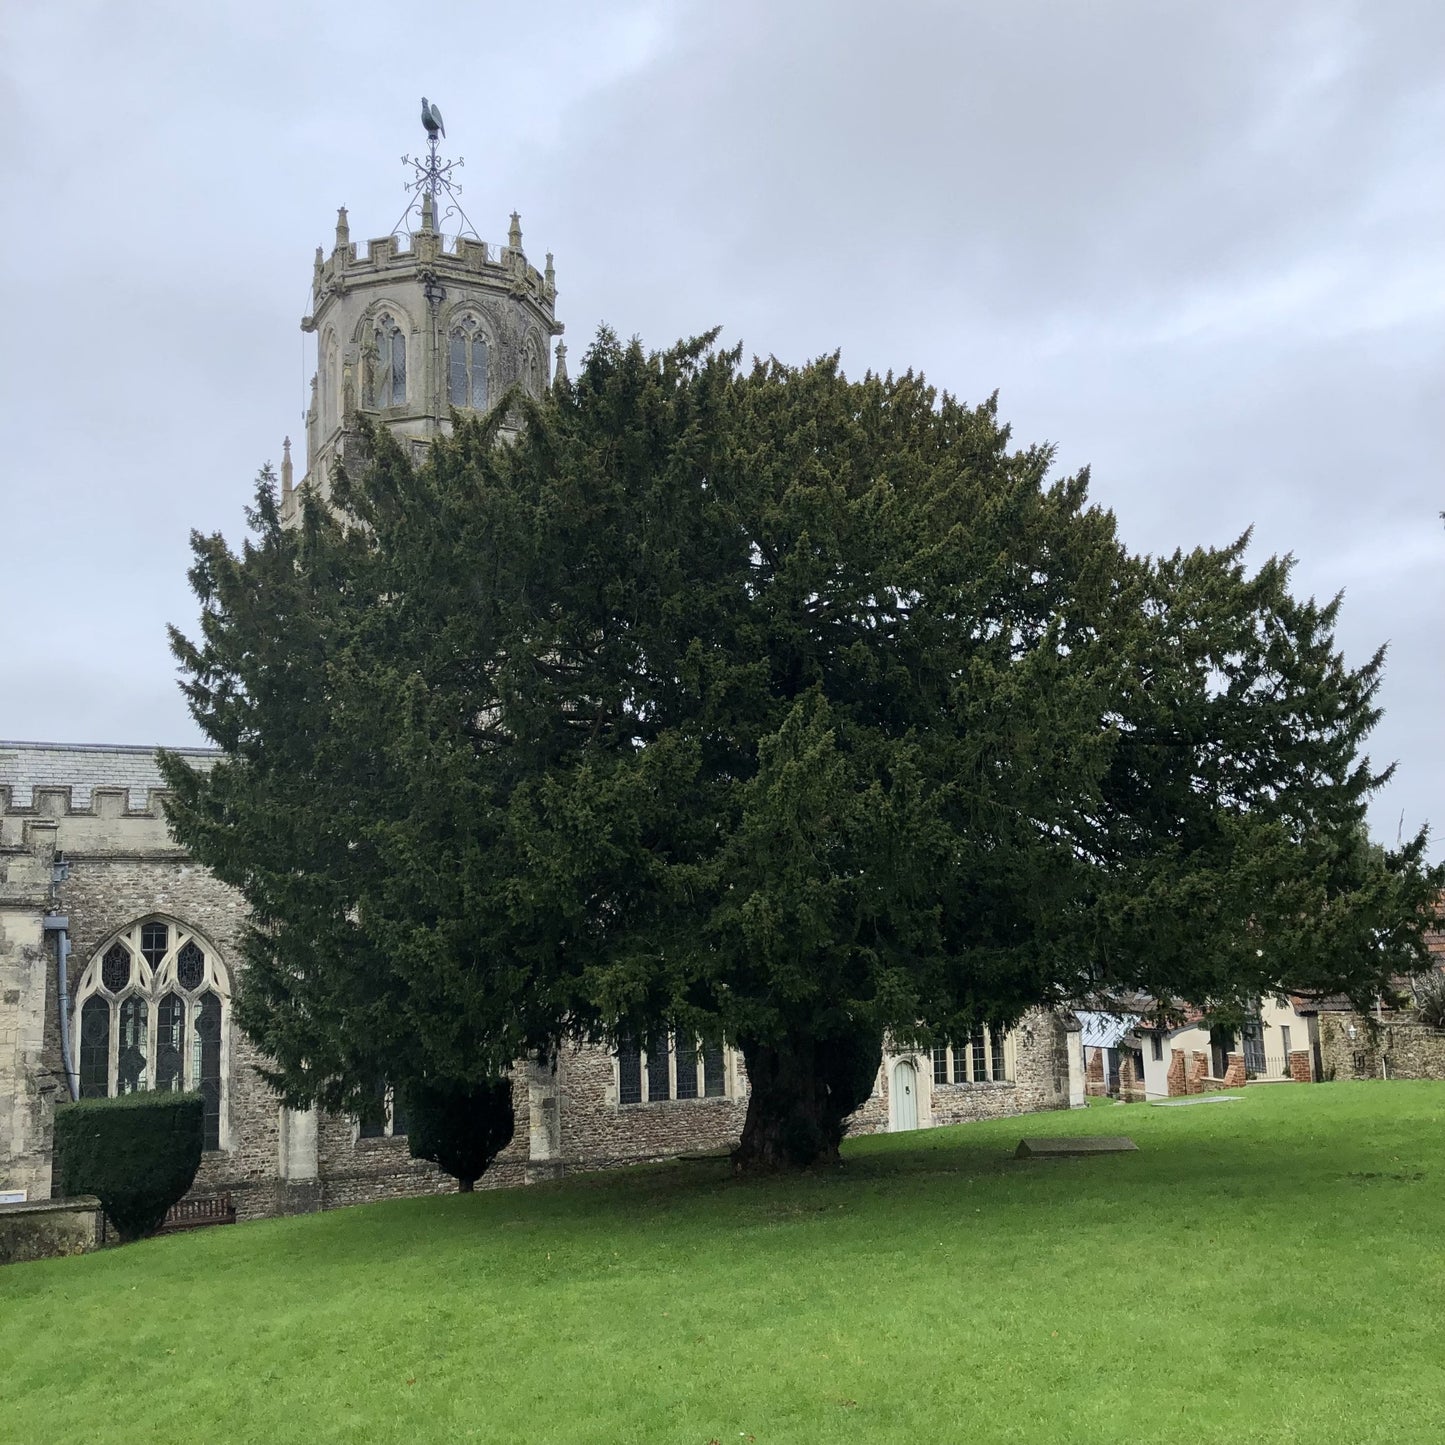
[0,0,1445,857]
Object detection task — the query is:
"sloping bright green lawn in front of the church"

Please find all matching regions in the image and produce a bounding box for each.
[0,1084,1445,1445]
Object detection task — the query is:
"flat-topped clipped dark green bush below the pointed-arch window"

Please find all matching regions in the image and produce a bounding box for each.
[55,1092,202,1240]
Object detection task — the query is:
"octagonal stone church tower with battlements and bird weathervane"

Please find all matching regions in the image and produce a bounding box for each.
[282,101,566,522]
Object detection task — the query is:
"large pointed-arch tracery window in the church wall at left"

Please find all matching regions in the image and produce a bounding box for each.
[72,919,231,1149]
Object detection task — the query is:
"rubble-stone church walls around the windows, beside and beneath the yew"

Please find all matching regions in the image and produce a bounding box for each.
[0,744,1071,1220]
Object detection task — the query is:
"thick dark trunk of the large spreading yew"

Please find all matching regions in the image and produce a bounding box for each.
[733,1029,883,1173]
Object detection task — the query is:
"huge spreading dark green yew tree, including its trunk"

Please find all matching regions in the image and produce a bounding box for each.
[168,332,1441,1168]
